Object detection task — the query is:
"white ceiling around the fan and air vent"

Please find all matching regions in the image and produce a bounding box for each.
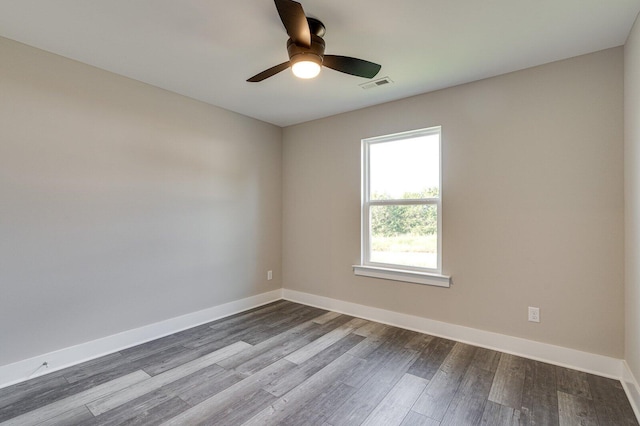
[0,0,640,126]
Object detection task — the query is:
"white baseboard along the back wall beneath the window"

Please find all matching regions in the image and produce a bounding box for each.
[282,289,622,380]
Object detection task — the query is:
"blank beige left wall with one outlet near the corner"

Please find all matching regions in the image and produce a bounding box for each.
[0,39,282,365]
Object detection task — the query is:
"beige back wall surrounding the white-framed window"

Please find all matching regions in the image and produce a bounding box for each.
[283,48,624,358]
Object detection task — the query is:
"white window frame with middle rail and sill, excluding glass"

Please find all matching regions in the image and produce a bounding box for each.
[353,126,451,287]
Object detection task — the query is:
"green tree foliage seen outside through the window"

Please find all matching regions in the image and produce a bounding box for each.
[371,188,438,237]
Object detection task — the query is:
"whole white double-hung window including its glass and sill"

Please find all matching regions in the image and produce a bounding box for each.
[354,127,449,287]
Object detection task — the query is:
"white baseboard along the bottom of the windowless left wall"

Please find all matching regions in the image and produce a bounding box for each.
[0,289,282,389]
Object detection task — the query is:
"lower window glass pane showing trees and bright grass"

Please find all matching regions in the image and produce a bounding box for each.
[369,204,438,269]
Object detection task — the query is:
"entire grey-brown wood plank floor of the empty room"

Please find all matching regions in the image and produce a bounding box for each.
[0,301,638,426]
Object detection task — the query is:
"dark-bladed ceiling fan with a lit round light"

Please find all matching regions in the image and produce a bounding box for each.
[247,0,381,83]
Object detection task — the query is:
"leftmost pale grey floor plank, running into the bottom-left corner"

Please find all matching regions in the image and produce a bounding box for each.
[2,370,150,426]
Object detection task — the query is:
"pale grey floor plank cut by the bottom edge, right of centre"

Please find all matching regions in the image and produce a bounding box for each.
[362,374,429,426]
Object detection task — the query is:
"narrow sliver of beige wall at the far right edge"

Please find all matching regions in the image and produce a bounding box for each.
[624,13,640,379]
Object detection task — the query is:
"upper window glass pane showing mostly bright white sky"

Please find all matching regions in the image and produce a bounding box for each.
[369,134,440,200]
